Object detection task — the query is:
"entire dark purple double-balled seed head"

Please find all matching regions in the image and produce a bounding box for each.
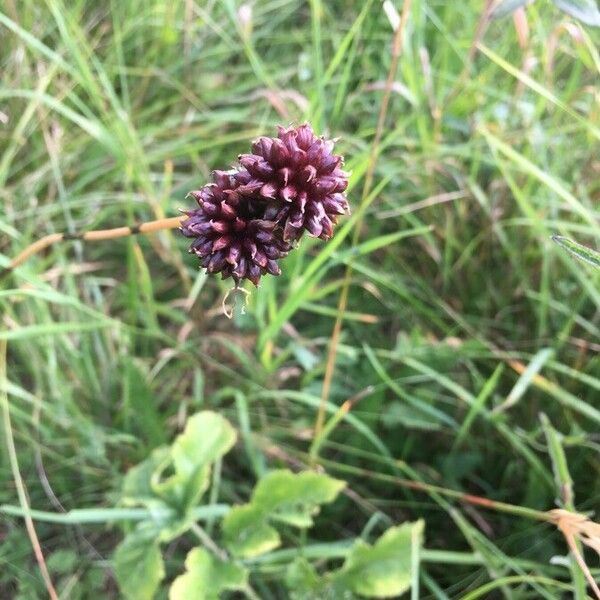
[181,123,349,285]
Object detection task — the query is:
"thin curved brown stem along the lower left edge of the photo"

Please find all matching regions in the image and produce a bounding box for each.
[0,340,58,600]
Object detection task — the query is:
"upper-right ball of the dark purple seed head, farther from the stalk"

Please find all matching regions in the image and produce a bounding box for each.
[234,123,349,242]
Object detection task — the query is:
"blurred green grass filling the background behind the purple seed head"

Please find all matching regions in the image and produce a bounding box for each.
[0,0,600,599]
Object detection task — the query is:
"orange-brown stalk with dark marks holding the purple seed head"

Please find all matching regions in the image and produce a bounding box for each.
[0,216,186,278]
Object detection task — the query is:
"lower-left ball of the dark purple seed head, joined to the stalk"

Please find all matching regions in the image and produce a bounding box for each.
[181,171,290,285]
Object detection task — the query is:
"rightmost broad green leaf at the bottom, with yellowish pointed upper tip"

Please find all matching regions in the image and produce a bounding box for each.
[335,521,424,598]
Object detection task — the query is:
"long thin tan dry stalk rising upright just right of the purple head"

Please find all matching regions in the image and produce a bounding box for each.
[314,0,412,450]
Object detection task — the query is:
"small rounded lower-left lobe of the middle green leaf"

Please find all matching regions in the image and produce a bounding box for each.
[223,504,281,558]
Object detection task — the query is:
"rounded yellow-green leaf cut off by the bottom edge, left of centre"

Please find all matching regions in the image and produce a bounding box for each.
[113,529,165,600]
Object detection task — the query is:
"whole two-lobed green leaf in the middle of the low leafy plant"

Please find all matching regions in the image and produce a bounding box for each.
[223,469,346,558]
